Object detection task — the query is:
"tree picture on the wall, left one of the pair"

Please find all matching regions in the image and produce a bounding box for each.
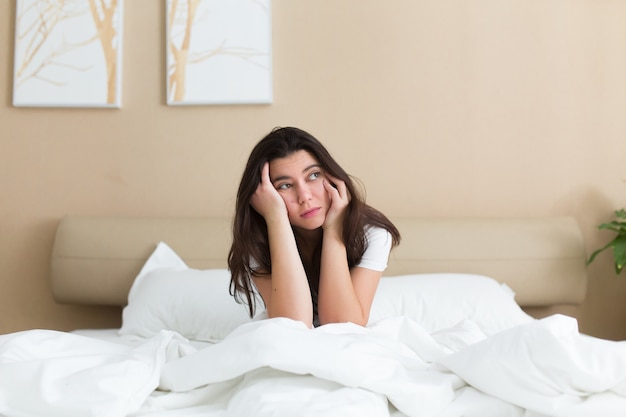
[13,0,123,107]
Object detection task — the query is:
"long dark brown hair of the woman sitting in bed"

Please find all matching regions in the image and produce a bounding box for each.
[228,127,400,317]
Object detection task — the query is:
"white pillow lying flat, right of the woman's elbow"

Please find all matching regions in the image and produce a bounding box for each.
[369,273,533,336]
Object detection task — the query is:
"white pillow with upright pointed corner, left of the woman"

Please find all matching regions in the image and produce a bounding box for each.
[120,242,263,342]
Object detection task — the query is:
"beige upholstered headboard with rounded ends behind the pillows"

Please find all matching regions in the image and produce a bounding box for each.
[51,216,587,306]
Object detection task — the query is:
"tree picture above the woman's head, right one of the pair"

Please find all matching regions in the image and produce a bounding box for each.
[166,0,272,105]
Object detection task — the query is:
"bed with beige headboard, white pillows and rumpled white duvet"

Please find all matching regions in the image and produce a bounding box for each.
[0,216,626,417]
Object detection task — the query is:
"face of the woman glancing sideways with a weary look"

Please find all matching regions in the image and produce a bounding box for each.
[269,151,330,230]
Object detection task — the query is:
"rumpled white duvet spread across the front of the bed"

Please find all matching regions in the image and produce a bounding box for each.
[0,315,626,417]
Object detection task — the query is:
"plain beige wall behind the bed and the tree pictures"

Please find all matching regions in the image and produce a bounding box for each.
[0,0,626,339]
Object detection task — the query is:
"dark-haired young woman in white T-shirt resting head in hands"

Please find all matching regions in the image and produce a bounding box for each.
[228,127,400,327]
